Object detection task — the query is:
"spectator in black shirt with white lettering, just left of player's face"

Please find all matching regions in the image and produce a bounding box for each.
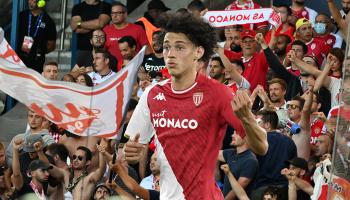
[141,31,165,78]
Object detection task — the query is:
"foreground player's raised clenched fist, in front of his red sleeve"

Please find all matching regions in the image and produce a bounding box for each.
[231,90,254,120]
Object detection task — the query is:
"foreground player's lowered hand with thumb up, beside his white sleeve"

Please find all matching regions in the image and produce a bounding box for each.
[123,133,144,164]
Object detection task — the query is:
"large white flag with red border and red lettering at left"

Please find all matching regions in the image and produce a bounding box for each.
[0,28,146,138]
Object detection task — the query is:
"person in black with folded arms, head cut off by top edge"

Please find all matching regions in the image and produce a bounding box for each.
[70,0,111,67]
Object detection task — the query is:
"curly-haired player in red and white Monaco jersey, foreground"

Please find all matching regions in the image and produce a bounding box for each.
[124,14,268,200]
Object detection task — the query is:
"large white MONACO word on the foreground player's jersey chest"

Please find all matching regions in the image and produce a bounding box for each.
[153,118,198,130]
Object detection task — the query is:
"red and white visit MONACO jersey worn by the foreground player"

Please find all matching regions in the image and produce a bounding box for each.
[125,74,245,200]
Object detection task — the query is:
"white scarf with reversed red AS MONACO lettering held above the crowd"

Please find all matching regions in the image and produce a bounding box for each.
[203,8,282,28]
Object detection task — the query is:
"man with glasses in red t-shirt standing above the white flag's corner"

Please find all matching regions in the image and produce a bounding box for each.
[103,2,150,71]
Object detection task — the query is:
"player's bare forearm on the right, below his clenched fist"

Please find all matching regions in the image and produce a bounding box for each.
[241,113,268,155]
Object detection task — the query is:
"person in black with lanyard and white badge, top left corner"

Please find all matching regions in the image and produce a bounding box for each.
[16,0,56,73]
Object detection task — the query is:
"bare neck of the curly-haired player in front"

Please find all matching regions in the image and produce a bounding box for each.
[171,70,197,91]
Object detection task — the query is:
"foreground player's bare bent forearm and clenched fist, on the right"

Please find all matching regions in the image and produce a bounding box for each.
[231,91,268,155]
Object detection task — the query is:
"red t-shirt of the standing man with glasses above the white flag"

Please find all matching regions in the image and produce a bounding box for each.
[103,23,148,71]
